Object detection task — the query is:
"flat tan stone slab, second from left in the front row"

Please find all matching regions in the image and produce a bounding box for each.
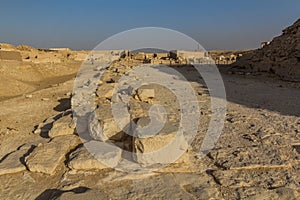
[25,135,80,175]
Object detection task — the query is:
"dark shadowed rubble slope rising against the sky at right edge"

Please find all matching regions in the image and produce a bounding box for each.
[233,19,300,81]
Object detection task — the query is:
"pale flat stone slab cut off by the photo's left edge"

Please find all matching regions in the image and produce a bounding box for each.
[0,147,29,175]
